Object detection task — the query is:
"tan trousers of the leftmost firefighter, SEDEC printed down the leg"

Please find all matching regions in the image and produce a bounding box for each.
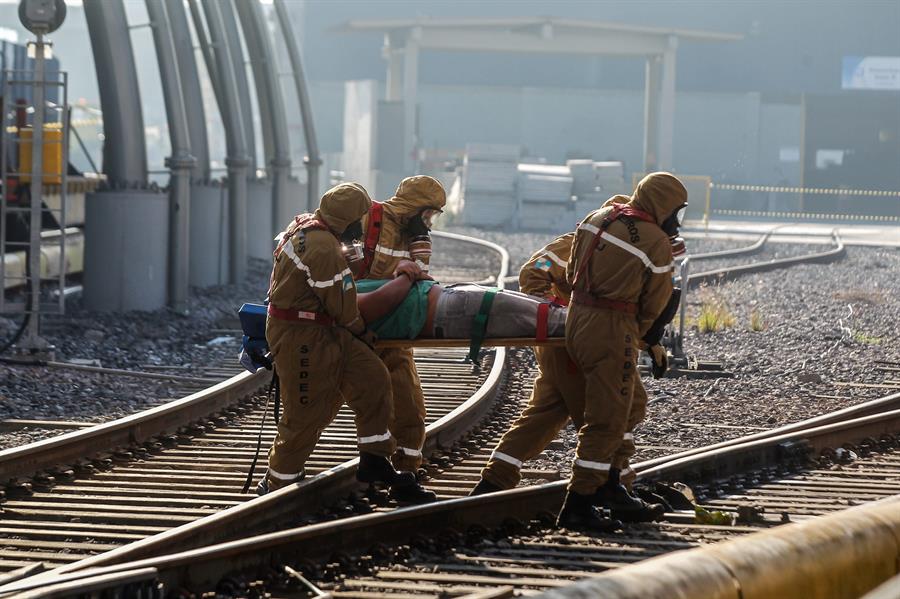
[266,319,396,488]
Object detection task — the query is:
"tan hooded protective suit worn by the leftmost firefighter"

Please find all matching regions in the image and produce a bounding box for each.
[266,183,396,490]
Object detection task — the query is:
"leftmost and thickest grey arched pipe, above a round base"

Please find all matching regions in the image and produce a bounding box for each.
[84,0,147,186]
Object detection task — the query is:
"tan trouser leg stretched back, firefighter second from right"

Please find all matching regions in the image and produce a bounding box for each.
[481,347,584,489]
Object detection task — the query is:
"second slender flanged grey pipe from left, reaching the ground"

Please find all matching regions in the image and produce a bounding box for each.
[199,0,251,283]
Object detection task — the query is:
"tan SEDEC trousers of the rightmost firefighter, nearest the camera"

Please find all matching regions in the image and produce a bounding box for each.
[566,304,639,495]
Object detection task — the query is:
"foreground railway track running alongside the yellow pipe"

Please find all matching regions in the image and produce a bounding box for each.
[8,394,900,597]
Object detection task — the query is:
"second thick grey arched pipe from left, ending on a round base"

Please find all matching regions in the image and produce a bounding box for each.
[165,0,209,181]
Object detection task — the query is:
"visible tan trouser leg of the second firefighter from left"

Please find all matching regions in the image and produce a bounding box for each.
[378,348,425,471]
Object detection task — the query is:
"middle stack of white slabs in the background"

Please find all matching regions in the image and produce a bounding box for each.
[518,164,575,230]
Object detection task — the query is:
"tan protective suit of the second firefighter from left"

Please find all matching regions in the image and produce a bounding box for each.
[363,175,447,471]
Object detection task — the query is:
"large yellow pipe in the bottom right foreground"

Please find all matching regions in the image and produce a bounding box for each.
[546,496,900,599]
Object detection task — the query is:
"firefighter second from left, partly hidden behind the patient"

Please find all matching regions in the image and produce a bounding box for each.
[359,175,447,502]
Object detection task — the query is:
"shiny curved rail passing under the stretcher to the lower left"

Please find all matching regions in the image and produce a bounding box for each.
[0,234,509,578]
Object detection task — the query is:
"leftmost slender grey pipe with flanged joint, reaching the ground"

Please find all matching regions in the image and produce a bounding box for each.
[145,0,196,314]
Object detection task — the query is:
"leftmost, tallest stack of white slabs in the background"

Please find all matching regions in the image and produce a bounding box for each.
[462,144,521,227]
